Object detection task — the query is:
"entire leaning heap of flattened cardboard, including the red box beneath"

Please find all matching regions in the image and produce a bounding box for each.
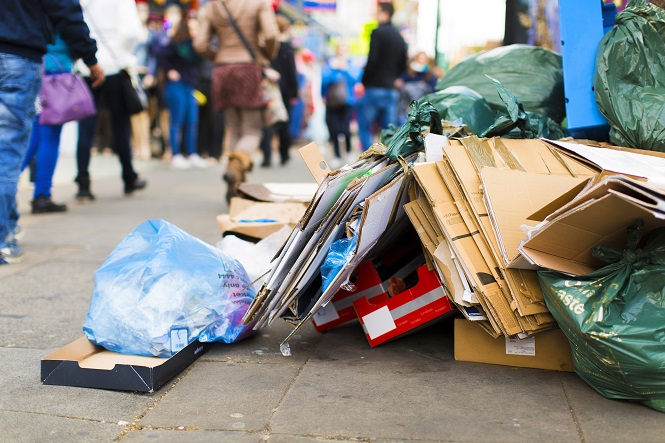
[240,134,665,356]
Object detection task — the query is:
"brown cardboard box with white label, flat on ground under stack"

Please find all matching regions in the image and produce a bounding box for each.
[455,318,573,372]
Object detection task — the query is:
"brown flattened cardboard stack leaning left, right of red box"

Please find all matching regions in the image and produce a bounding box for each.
[407,137,595,337]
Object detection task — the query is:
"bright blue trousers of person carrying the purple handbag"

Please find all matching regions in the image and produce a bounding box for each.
[21,117,62,198]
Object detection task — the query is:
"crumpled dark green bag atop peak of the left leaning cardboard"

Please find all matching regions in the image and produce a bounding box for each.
[381,101,443,161]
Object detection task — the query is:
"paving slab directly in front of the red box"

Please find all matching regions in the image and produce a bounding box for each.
[271,320,579,442]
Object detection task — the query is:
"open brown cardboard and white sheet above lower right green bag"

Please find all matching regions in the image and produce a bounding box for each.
[519,141,665,275]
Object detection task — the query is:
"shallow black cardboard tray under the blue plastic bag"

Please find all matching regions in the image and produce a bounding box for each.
[41,337,211,392]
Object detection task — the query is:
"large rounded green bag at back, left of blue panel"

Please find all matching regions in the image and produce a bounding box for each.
[436,45,566,123]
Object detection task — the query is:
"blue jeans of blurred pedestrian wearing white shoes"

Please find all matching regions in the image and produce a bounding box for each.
[164,81,199,155]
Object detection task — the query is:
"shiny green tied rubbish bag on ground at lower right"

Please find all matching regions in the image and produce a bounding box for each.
[538,221,665,412]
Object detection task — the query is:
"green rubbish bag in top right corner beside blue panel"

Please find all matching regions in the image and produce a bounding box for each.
[593,0,665,152]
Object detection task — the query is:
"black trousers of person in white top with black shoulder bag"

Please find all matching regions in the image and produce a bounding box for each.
[76,74,137,185]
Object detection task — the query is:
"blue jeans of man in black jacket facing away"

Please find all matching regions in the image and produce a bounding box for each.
[356,88,399,151]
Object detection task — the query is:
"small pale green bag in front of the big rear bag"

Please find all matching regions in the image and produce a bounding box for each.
[419,86,496,134]
